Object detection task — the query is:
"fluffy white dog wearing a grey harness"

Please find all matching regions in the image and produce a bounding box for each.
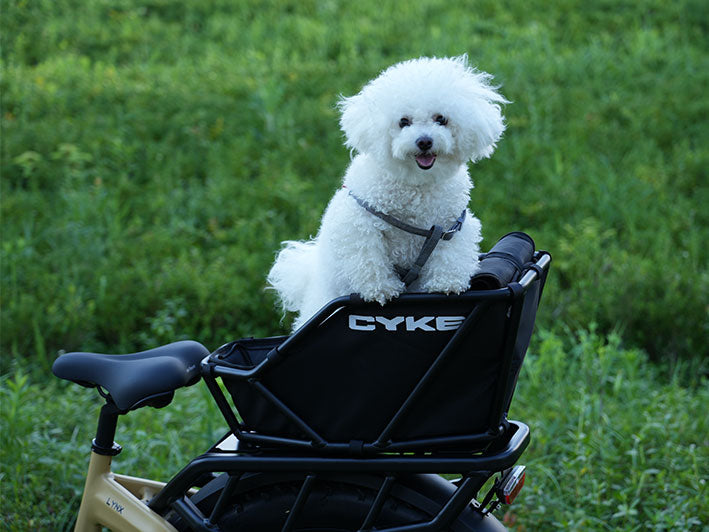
[268,56,506,329]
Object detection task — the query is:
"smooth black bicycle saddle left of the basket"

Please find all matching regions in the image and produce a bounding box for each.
[52,341,209,412]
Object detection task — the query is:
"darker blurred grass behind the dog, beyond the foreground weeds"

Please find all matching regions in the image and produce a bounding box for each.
[0,0,709,362]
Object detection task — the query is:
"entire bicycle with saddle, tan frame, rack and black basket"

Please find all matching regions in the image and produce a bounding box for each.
[52,233,551,532]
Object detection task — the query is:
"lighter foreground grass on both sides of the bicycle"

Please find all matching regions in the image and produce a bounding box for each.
[0,330,709,532]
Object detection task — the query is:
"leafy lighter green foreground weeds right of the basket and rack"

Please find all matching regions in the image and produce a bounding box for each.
[510,329,709,531]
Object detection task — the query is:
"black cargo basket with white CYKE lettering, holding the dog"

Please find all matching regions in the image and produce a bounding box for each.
[203,233,550,454]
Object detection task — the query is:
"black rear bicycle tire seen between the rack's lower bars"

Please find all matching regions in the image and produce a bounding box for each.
[180,474,505,532]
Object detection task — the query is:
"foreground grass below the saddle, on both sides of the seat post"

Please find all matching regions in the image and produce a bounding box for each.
[0,371,227,532]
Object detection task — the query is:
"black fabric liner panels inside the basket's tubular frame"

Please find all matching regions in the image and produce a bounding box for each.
[213,233,543,443]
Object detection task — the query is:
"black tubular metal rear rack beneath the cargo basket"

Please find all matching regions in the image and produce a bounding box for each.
[149,421,530,532]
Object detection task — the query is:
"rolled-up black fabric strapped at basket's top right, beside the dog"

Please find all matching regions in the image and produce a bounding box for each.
[470,231,534,290]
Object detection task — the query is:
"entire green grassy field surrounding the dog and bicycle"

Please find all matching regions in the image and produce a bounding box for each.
[0,0,709,530]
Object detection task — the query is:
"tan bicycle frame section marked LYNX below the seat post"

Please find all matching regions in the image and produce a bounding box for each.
[74,452,177,532]
